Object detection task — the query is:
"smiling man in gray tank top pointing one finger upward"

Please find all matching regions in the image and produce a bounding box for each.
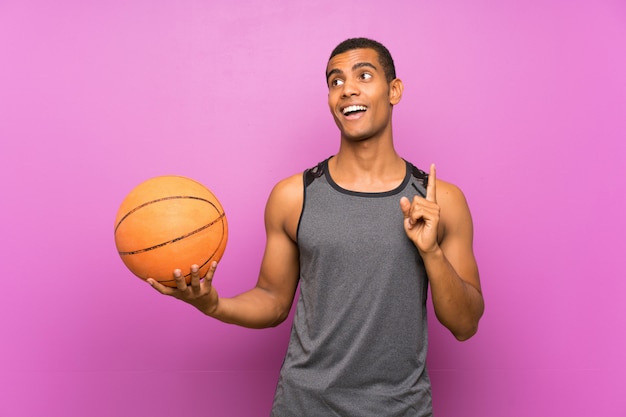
[148,38,484,417]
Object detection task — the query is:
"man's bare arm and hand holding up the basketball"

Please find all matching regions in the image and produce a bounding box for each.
[148,175,303,328]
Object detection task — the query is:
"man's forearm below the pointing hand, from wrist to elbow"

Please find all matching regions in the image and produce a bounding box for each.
[422,248,484,340]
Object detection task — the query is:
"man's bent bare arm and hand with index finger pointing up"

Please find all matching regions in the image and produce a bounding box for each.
[400,166,484,340]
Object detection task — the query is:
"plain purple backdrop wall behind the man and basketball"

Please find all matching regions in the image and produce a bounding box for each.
[0,0,626,417]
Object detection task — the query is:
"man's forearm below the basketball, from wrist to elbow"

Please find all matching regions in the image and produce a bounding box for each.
[205,286,290,329]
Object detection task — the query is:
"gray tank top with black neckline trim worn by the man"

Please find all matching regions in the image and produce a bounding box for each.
[272,160,432,417]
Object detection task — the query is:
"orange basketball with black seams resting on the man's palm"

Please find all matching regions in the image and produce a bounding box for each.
[115,176,228,287]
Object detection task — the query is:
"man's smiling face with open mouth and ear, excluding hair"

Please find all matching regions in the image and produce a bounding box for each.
[326,48,402,141]
